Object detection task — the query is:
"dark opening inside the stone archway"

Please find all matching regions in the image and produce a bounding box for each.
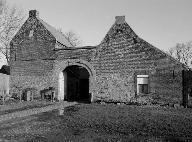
[63,65,91,102]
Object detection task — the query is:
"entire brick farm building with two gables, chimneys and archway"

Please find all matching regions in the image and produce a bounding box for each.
[10,10,190,103]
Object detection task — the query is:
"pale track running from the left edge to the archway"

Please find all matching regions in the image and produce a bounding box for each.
[0,101,76,122]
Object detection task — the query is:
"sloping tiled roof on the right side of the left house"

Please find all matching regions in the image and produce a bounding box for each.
[38,17,73,47]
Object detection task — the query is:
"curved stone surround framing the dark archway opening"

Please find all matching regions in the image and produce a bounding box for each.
[54,59,96,102]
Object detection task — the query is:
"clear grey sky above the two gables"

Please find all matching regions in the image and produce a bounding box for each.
[8,0,192,50]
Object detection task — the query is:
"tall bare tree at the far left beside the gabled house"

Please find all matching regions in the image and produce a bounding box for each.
[0,0,24,64]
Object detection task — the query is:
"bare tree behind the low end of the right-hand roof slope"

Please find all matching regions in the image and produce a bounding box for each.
[168,41,192,67]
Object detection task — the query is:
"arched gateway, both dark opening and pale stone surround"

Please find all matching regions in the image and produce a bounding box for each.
[54,60,95,102]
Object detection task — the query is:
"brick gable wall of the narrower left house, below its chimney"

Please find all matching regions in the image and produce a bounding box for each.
[10,10,56,95]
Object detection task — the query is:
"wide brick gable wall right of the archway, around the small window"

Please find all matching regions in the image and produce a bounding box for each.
[91,17,184,103]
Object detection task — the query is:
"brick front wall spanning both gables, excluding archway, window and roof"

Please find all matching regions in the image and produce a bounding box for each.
[10,13,184,103]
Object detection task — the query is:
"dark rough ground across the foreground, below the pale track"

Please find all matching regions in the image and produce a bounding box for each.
[0,104,192,142]
